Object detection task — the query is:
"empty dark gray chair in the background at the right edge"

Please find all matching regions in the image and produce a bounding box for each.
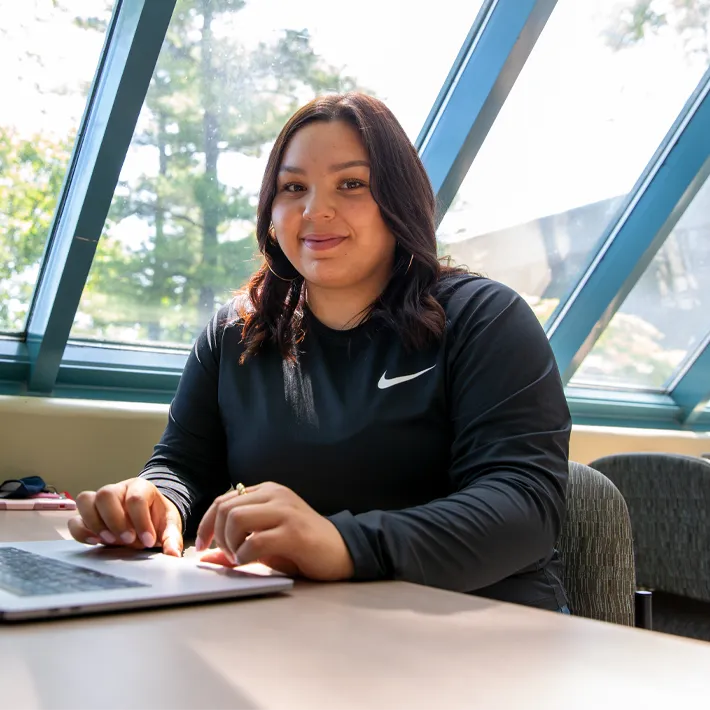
[592,453,710,641]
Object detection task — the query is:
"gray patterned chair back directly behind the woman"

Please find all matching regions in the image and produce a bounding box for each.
[558,462,636,626]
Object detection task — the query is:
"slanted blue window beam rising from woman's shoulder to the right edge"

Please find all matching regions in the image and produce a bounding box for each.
[546,68,710,384]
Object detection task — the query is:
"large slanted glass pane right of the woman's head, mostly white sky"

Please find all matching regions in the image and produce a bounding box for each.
[439,0,709,322]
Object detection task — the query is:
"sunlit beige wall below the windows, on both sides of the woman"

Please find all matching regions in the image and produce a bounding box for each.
[0,396,710,495]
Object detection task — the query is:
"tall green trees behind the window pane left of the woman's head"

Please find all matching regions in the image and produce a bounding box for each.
[78,0,364,343]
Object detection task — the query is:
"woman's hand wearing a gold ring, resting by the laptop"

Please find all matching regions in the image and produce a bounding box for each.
[195,483,353,581]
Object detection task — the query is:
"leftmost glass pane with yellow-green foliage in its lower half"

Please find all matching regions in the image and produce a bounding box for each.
[0,0,111,332]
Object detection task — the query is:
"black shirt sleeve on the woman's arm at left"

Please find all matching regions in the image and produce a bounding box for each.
[140,307,235,532]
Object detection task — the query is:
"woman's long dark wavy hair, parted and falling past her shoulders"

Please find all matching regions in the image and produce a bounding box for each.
[239,92,463,362]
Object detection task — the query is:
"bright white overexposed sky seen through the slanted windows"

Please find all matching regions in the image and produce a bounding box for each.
[0,0,705,245]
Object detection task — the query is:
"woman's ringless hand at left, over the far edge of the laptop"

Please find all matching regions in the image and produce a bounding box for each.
[69,478,183,557]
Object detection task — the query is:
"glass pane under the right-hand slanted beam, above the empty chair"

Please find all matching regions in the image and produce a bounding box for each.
[572,174,710,389]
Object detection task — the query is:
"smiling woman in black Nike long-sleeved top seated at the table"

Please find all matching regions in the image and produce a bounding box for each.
[70,93,570,610]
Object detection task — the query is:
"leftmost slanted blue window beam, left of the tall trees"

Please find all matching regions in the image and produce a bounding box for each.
[25,0,176,394]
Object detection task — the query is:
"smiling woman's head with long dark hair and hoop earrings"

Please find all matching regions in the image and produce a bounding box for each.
[240,94,463,359]
